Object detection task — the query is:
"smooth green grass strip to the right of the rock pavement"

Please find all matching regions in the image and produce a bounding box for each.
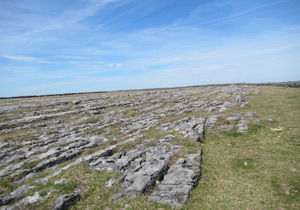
[182,87,300,209]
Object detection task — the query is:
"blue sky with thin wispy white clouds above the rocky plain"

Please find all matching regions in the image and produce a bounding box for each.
[0,0,300,97]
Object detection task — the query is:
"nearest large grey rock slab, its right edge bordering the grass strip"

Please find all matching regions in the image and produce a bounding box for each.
[150,151,201,207]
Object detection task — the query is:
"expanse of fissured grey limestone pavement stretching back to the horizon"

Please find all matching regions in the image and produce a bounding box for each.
[0,85,259,209]
